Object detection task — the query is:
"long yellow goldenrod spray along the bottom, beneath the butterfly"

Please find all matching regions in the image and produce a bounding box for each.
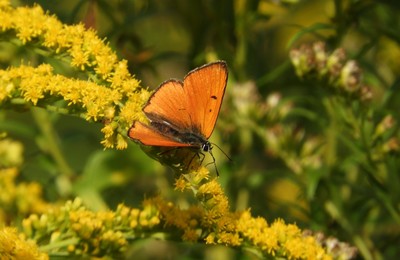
[15,180,331,259]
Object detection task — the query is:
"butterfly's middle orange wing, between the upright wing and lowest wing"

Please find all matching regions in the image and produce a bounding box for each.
[143,80,191,129]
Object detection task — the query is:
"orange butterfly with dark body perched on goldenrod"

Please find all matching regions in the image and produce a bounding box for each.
[128,61,229,175]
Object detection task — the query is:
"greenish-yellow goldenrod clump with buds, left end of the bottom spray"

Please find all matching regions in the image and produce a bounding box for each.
[22,199,131,255]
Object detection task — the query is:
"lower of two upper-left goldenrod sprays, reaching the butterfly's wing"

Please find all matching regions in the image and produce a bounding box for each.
[0,64,143,149]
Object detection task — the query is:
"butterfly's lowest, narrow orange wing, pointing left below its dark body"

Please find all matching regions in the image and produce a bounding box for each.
[128,121,190,147]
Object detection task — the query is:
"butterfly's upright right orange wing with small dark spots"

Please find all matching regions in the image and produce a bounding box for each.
[183,61,228,139]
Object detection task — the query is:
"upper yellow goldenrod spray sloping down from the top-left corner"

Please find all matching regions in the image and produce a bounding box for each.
[0,1,134,84]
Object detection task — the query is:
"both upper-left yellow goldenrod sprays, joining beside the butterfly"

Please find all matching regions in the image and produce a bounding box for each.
[0,0,149,149]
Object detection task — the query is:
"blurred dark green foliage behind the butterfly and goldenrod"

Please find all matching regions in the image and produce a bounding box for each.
[0,0,400,259]
